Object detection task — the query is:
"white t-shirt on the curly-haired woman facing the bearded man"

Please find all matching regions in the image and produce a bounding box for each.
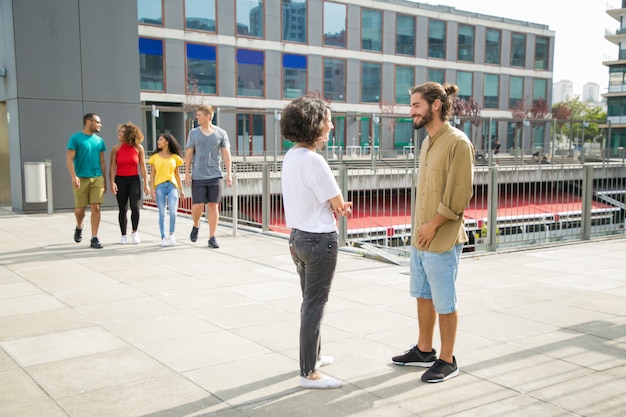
[281,147,341,233]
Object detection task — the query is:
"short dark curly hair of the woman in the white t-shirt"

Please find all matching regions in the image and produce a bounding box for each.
[280,96,330,145]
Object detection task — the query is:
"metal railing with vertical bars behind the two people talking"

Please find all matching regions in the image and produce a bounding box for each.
[144,150,626,257]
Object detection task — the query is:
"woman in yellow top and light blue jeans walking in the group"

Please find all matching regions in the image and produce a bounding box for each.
[148,133,185,246]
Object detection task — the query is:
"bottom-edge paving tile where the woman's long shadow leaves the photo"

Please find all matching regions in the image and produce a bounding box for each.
[59,375,219,417]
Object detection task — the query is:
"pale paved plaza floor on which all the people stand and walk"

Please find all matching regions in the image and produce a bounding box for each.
[0,209,626,417]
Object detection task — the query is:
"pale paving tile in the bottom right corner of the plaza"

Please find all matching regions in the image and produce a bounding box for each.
[530,373,626,417]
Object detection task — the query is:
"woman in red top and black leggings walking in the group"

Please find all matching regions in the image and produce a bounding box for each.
[109,122,150,245]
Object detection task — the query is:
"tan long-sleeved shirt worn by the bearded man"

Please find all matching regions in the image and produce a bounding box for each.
[411,122,474,253]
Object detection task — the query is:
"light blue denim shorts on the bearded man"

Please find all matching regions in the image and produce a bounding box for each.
[410,244,463,314]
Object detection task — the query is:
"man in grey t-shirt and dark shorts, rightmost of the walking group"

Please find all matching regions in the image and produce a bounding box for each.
[185,105,233,249]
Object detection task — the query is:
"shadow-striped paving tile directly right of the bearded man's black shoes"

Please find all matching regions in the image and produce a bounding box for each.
[457,343,594,393]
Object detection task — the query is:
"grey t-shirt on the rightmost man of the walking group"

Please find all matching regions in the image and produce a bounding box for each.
[186,126,230,180]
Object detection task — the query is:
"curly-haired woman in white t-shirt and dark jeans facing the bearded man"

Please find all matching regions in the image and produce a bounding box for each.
[280,96,352,388]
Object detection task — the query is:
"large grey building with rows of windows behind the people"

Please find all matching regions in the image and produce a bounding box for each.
[0,0,555,212]
